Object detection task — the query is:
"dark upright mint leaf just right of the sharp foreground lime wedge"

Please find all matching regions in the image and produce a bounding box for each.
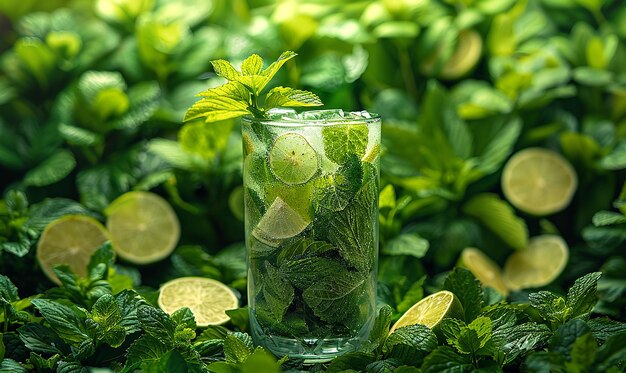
[443,267,484,321]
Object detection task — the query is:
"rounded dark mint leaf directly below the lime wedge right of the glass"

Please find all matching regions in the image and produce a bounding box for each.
[383,324,437,365]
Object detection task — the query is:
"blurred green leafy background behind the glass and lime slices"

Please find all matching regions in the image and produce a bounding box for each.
[0,0,626,370]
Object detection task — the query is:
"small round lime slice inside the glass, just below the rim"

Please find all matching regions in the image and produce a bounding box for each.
[270,133,319,185]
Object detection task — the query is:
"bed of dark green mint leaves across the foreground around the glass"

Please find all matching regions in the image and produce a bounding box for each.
[0,241,626,373]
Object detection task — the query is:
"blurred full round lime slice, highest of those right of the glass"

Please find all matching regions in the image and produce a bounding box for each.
[502,148,578,215]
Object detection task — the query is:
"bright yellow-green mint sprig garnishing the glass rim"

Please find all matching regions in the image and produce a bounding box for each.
[183,51,323,123]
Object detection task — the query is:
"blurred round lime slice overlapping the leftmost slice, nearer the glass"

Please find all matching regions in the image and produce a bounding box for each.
[104,192,180,264]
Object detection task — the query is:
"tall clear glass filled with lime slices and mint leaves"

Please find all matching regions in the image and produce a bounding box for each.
[242,109,381,363]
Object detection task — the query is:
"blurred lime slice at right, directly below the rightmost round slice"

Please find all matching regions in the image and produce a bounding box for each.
[503,234,569,290]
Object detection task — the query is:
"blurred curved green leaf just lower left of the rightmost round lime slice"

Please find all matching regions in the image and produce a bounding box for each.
[463,193,528,250]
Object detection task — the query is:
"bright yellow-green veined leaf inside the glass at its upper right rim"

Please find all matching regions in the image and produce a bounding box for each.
[322,124,369,164]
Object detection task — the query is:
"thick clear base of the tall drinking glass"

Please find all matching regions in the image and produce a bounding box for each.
[250,317,373,365]
